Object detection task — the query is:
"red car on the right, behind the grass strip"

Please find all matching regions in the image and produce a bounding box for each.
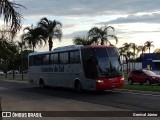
[128,70,160,85]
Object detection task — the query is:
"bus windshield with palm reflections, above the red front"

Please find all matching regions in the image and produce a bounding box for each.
[94,48,122,77]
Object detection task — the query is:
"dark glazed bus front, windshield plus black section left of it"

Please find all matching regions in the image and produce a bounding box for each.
[82,47,122,79]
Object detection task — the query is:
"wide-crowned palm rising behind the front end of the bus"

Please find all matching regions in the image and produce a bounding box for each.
[88,26,118,45]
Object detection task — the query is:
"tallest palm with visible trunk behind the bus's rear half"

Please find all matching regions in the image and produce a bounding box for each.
[38,18,62,51]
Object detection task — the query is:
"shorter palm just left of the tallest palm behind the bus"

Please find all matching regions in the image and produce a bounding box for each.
[22,26,45,52]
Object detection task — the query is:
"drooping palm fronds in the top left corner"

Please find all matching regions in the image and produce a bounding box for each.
[0,0,23,36]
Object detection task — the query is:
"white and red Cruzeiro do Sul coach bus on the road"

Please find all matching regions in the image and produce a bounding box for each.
[28,45,124,92]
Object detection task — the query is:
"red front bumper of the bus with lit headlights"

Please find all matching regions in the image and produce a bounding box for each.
[96,77,124,90]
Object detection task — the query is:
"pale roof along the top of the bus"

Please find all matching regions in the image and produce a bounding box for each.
[29,45,115,56]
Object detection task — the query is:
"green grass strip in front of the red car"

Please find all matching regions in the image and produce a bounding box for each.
[123,85,160,92]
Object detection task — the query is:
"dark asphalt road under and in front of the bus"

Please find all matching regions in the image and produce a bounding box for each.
[0,81,160,119]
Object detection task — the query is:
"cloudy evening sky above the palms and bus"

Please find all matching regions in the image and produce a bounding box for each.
[2,0,160,51]
